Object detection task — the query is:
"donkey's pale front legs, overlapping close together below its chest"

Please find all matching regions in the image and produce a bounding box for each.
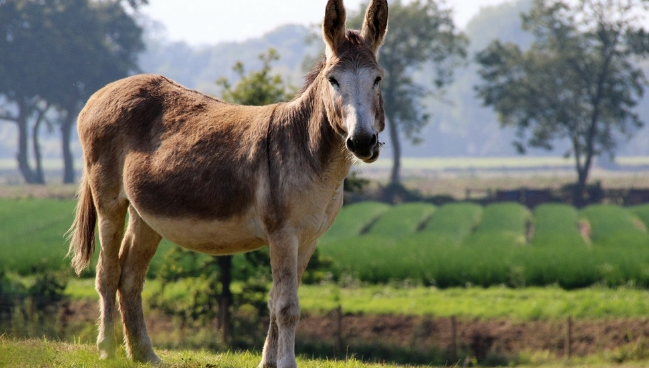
[260,230,300,368]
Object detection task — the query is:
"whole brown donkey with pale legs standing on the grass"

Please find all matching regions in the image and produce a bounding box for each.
[70,0,388,367]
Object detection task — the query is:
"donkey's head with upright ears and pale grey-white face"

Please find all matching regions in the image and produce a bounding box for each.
[321,0,388,162]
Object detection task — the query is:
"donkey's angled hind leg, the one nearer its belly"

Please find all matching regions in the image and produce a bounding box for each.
[119,206,161,363]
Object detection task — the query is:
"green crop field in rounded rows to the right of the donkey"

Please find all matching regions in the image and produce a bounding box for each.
[320,203,649,289]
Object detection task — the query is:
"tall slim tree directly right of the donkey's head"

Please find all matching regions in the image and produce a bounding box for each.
[349,0,468,185]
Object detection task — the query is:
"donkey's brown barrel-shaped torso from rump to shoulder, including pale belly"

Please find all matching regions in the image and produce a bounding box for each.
[78,75,274,260]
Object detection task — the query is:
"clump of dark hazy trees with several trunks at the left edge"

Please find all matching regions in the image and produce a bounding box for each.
[0,0,146,183]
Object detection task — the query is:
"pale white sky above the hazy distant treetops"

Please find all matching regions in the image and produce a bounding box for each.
[141,0,508,46]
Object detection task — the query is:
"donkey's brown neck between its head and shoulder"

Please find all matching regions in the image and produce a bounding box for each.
[271,80,353,182]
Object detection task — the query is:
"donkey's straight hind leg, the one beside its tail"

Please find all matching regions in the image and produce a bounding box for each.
[95,195,128,359]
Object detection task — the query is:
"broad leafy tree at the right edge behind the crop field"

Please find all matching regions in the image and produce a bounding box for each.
[475,0,649,205]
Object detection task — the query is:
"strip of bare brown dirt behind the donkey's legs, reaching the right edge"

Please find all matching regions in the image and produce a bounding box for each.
[66,301,649,357]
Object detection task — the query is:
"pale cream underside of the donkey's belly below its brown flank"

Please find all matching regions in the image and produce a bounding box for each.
[139,208,268,255]
